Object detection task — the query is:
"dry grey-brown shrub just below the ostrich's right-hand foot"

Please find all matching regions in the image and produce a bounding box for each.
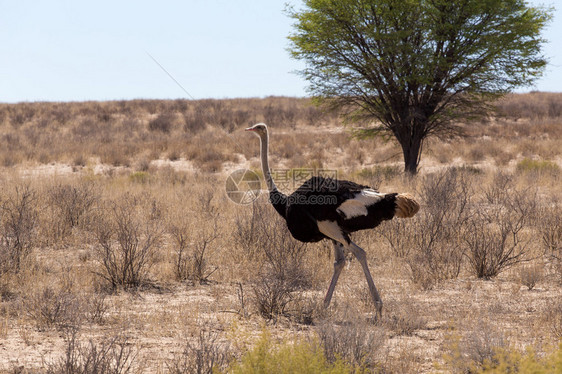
[316,316,386,369]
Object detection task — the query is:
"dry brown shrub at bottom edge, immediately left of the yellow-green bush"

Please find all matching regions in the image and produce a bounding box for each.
[168,328,232,374]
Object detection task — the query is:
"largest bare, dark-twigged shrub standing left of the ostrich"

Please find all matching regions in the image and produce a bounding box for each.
[93,194,162,289]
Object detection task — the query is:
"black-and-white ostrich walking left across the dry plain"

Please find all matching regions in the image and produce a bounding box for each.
[246,123,419,317]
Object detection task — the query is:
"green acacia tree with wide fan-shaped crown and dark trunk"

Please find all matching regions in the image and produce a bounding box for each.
[288,0,552,174]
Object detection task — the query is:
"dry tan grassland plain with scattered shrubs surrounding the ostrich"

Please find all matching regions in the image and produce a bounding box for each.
[0,93,562,373]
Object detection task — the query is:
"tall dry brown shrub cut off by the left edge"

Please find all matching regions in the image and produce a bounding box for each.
[0,185,38,275]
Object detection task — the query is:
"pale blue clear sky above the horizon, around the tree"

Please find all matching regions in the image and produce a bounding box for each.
[0,0,562,102]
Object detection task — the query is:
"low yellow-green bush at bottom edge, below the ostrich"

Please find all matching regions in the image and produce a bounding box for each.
[227,331,361,374]
